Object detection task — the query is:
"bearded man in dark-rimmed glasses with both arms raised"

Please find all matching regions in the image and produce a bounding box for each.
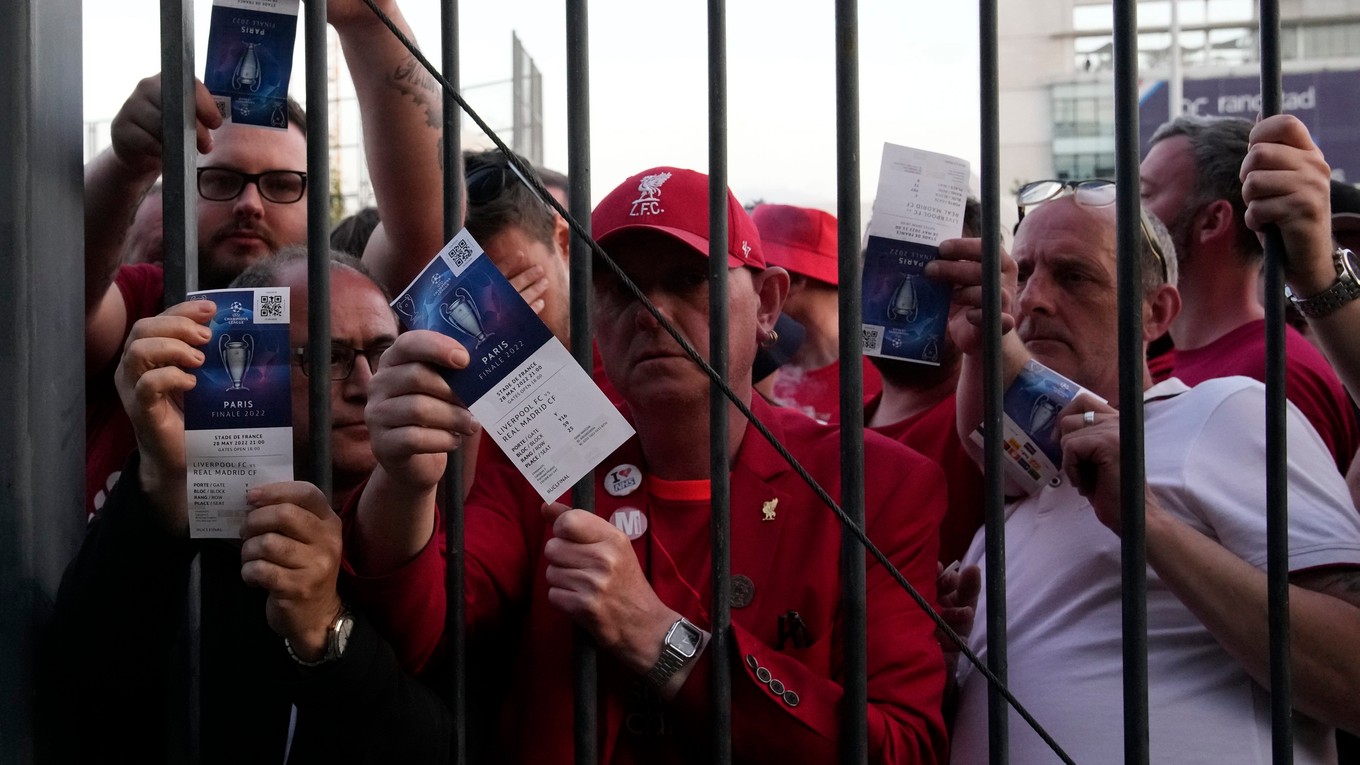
[86,0,443,513]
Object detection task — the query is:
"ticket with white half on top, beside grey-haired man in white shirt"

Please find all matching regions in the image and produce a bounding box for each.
[861,143,968,366]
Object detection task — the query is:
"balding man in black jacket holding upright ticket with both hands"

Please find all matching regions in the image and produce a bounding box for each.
[44,248,454,764]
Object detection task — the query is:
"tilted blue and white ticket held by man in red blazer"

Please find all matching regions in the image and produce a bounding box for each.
[392,229,632,502]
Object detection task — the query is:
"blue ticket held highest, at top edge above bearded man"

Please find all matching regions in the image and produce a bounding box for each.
[203,0,298,131]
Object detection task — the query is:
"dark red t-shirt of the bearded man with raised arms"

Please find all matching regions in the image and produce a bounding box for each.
[86,263,165,516]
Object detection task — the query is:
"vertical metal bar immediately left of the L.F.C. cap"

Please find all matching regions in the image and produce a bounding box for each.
[566,0,600,765]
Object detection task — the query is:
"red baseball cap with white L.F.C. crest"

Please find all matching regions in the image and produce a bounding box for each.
[590,167,766,268]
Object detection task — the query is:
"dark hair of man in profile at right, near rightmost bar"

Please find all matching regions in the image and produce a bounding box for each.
[1149,117,1263,264]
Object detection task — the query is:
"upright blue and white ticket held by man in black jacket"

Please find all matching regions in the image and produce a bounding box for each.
[184,287,292,539]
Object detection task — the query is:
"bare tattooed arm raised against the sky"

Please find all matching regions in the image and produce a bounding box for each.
[326,0,443,294]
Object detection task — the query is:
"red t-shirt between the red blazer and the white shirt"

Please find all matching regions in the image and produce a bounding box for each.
[864,393,985,566]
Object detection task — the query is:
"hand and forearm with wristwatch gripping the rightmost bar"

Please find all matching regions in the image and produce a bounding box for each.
[1242,114,1360,396]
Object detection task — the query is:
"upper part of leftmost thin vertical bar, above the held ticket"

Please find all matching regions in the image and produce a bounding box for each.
[160,0,199,308]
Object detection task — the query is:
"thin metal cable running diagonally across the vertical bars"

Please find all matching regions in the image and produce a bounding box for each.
[363,0,1073,764]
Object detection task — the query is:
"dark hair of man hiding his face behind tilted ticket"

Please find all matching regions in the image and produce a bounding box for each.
[462,150,556,246]
